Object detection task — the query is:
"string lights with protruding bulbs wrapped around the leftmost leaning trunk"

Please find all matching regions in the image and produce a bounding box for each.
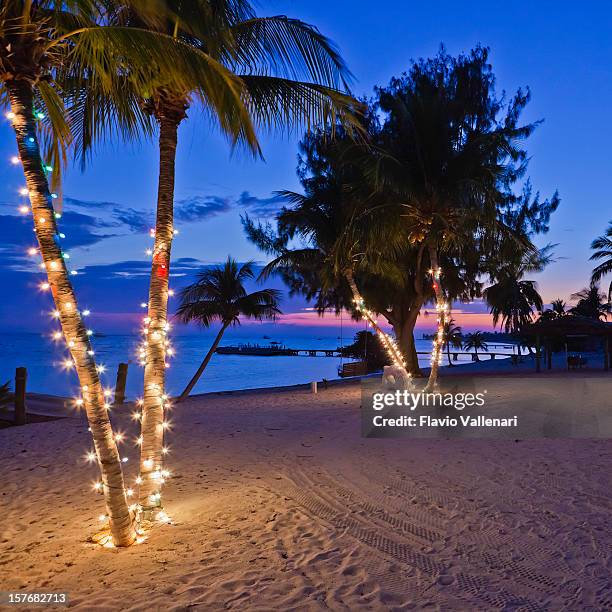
[7,104,137,546]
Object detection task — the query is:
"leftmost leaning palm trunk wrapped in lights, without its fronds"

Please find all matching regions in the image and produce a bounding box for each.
[6,80,136,546]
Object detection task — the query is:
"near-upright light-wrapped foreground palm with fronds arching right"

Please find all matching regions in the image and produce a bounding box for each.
[126,0,355,512]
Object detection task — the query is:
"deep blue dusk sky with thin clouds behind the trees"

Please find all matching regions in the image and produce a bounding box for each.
[0,0,612,331]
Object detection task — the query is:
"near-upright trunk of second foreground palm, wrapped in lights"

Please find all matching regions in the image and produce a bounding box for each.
[139,102,185,518]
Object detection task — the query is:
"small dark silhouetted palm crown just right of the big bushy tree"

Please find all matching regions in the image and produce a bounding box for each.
[483,245,552,333]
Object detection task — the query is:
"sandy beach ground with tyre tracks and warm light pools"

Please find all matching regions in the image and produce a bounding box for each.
[0,381,612,612]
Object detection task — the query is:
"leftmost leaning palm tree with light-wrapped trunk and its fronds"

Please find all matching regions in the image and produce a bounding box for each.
[0,0,213,546]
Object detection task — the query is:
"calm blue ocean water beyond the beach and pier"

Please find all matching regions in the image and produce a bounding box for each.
[0,327,510,399]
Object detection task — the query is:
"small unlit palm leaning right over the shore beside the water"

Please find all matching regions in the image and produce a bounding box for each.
[176,257,281,400]
